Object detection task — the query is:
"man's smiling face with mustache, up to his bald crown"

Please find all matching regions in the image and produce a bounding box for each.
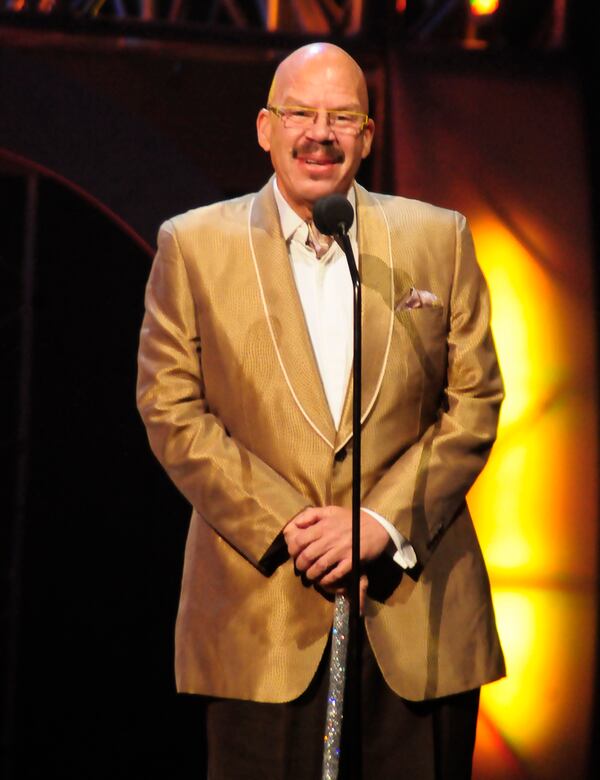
[257,51,374,218]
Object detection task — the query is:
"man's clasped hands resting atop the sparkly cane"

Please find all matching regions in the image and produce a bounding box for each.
[283,506,390,613]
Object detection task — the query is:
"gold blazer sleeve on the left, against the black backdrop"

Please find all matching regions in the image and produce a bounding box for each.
[137,222,310,574]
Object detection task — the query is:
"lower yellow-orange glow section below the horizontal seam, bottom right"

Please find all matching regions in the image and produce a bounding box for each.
[481,587,595,777]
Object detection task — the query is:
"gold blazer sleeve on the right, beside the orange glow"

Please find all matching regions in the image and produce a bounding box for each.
[362,214,504,567]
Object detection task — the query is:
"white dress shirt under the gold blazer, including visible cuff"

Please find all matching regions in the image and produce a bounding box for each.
[273,180,417,569]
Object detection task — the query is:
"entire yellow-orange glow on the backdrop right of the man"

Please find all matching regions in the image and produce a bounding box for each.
[468,216,598,780]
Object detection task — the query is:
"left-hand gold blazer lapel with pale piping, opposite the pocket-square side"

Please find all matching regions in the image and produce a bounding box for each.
[248,181,336,447]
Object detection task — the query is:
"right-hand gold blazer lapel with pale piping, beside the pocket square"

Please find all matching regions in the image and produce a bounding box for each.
[335,184,394,451]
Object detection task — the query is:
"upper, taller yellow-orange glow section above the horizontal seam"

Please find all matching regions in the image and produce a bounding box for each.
[469,220,597,579]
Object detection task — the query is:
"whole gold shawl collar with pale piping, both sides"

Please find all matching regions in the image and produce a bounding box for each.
[248,180,394,450]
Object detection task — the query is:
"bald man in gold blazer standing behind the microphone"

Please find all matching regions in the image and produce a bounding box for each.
[138,44,504,780]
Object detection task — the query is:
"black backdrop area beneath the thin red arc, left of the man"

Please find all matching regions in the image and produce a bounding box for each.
[0,176,203,778]
